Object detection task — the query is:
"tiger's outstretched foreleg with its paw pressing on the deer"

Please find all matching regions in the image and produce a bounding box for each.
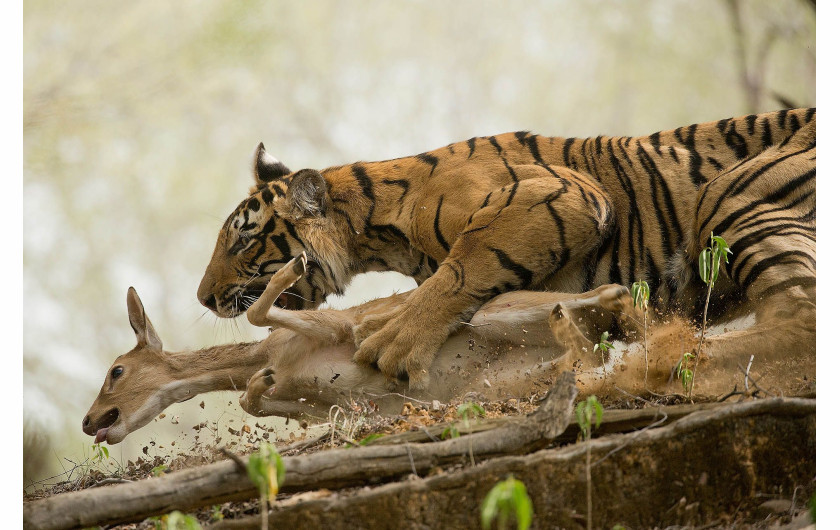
[354,178,611,389]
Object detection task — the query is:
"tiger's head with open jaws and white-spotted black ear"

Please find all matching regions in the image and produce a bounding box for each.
[197,143,351,318]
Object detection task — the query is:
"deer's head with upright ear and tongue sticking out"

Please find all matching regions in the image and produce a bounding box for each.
[82,287,185,444]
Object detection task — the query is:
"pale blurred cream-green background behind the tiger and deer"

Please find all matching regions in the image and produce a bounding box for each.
[23,0,816,483]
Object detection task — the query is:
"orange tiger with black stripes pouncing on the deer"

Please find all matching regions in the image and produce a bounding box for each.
[197,108,816,389]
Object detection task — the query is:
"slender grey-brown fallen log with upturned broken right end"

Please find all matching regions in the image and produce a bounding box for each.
[23,372,577,530]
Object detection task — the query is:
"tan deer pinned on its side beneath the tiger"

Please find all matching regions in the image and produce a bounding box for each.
[82,253,638,444]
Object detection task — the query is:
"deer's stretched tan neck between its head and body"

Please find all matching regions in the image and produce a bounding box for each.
[169,342,269,399]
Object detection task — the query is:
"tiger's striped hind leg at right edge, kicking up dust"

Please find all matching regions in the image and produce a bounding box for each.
[691,122,816,390]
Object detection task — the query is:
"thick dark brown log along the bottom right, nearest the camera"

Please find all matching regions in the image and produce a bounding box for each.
[212,398,816,530]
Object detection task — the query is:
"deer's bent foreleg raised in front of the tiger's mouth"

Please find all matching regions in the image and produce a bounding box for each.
[246,252,352,344]
